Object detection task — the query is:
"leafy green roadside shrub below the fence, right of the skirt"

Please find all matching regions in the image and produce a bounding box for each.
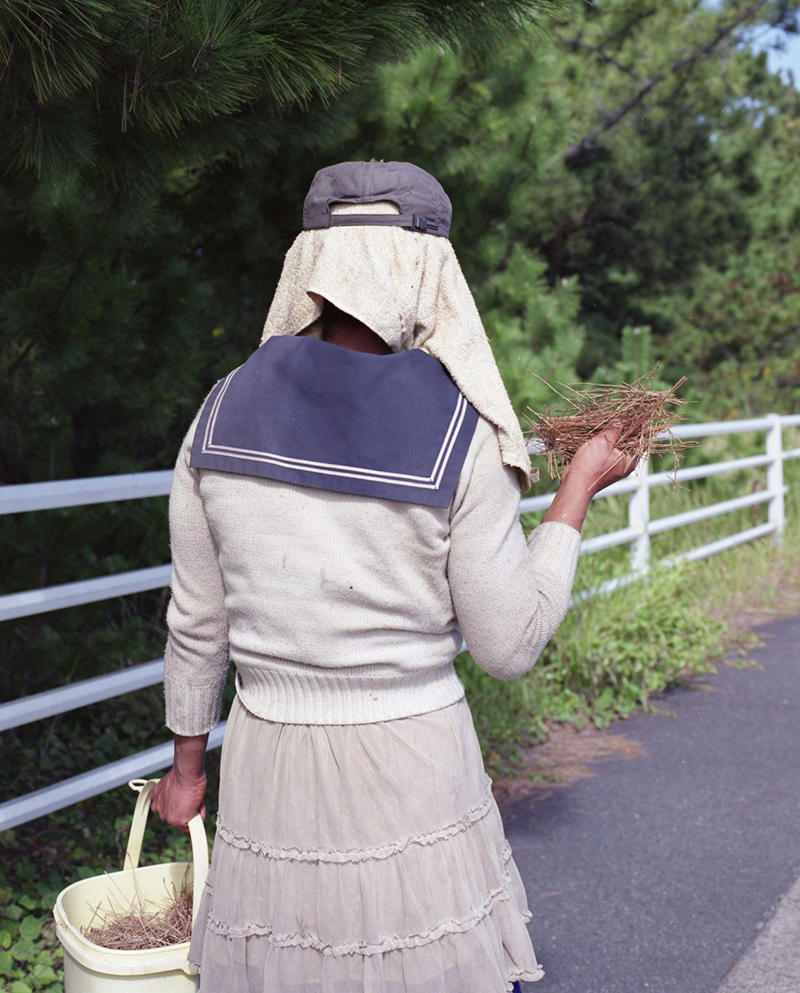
[457,563,727,775]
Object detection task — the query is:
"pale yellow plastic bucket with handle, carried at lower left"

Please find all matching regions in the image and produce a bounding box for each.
[53,779,208,993]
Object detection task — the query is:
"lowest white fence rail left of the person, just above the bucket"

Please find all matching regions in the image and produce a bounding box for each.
[0,721,228,831]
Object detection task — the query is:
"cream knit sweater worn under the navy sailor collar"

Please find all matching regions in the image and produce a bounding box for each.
[164,418,580,735]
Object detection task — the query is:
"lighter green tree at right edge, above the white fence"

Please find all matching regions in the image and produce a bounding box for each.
[661,94,800,417]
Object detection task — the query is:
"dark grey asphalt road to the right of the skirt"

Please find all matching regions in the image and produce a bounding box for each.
[503,617,800,993]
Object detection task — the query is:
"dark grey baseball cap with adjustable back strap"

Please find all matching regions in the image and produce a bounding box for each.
[303,159,453,238]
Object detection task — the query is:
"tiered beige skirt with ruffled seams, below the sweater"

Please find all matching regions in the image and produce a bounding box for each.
[189,698,544,993]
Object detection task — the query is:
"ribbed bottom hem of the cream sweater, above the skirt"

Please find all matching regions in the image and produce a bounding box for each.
[234,659,464,724]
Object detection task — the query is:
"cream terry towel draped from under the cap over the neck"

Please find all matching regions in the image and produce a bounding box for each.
[261,202,538,493]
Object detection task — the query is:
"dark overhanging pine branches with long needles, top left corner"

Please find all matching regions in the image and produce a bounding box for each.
[0,0,560,182]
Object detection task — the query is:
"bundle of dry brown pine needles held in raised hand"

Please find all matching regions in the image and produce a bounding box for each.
[528,367,688,479]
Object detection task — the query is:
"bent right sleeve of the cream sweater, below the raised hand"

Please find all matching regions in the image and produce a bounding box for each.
[447,418,581,679]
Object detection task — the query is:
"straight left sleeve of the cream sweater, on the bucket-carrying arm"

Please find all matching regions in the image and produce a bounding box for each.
[164,406,230,735]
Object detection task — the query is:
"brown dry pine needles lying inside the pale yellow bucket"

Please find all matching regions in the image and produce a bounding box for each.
[82,878,192,951]
